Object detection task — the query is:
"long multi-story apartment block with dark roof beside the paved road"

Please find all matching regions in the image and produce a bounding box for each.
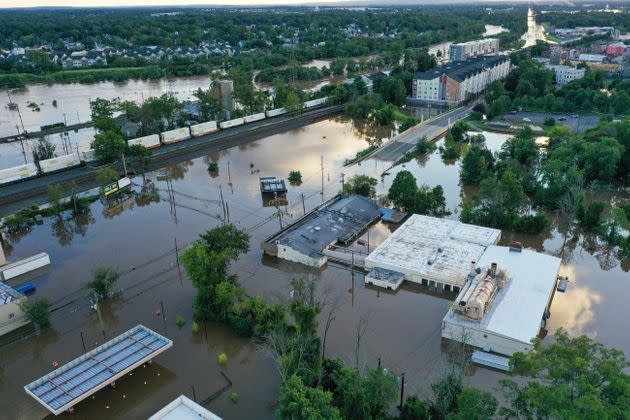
[408,55,510,106]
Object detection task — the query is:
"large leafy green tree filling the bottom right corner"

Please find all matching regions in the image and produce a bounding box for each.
[499,329,630,419]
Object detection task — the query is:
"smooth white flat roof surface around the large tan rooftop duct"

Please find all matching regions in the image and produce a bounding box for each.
[444,245,561,344]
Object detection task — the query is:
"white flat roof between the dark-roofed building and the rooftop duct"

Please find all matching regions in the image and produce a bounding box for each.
[366,214,501,285]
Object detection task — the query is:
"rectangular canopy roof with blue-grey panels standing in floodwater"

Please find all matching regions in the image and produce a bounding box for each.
[24,325,173,415]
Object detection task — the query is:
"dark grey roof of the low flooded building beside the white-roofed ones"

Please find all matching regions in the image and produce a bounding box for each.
[267,195,380,256]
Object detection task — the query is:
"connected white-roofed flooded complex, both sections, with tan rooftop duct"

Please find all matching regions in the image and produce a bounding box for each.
[365,215,560,356]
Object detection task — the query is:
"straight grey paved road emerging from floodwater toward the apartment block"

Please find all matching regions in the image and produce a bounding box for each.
[369,106,472,161]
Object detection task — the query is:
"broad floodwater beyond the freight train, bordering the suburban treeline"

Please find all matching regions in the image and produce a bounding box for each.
[0,76,210,137]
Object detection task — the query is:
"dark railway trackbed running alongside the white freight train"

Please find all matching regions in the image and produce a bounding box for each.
[0,105,343,216]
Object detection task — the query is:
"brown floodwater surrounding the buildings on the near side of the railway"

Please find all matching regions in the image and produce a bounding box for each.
[0,118,630,419]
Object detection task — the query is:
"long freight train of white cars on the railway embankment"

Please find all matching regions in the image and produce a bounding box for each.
[0,98,328,186]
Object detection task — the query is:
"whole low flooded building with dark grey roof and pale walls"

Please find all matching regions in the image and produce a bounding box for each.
[261,195,381,267]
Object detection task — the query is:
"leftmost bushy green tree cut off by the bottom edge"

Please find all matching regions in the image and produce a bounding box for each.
[278,375,342,420]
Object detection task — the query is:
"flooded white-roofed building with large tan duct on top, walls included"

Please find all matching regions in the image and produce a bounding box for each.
[442,245,561,356]
